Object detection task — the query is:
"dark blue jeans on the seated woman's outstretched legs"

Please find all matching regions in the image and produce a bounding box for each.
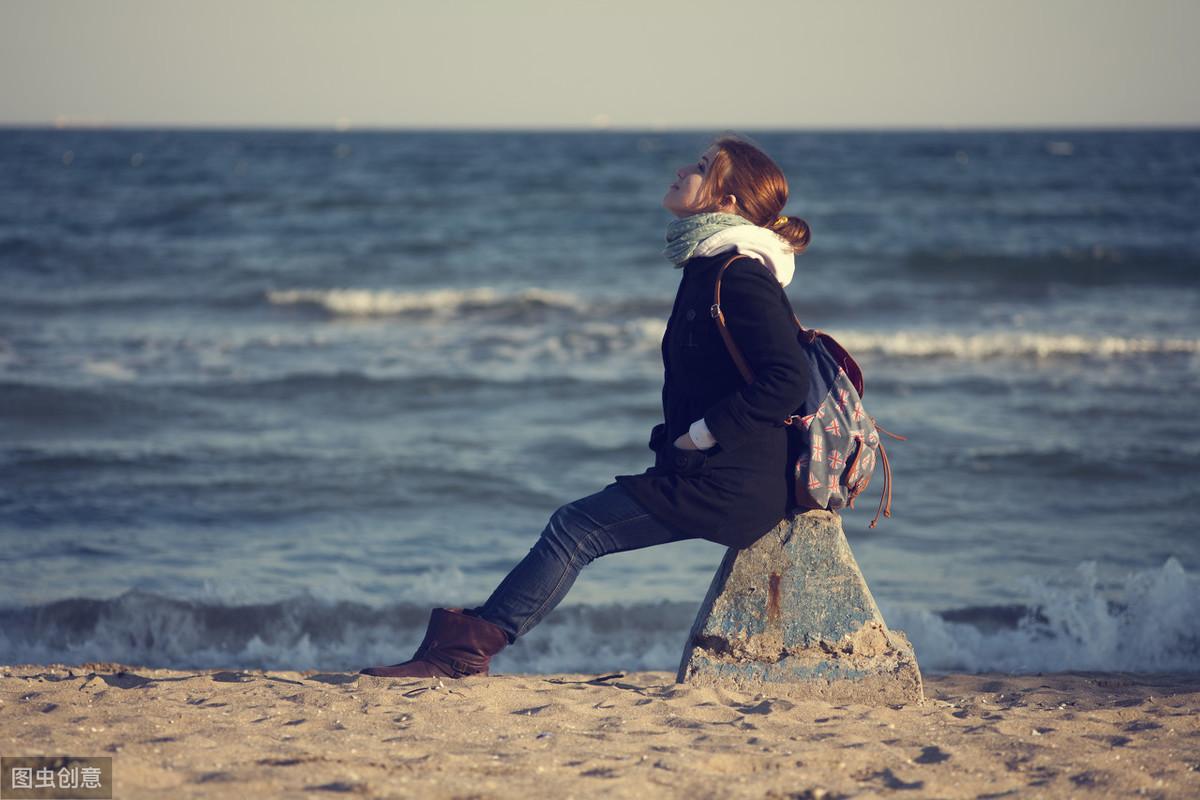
[466,482,695,644]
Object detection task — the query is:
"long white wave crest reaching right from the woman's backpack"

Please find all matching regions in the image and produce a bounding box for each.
[833,330,1200,361]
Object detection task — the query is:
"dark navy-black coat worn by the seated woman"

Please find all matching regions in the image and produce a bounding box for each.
[614,253,809,547]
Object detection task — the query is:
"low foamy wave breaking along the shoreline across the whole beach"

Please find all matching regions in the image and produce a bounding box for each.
[0,558,1200,673]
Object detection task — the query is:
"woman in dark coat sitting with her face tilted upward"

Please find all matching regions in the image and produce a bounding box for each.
[361,136,810,678]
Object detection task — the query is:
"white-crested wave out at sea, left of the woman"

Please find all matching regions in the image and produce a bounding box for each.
[273,287,582,317]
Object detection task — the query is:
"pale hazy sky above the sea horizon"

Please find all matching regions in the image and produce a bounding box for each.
[0,0,1200,130]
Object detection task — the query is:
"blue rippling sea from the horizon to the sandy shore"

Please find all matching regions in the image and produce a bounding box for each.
[0,127,1200,673]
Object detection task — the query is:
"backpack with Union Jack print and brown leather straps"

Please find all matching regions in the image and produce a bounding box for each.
[710,253,905,528]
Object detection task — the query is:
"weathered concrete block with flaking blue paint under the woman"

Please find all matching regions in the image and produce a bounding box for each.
[676,511,924,704]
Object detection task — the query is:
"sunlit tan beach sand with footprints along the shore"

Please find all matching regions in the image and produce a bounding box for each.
[0,663,1200,800]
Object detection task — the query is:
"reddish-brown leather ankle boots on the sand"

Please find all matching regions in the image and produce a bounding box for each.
[359,608,509,678]
